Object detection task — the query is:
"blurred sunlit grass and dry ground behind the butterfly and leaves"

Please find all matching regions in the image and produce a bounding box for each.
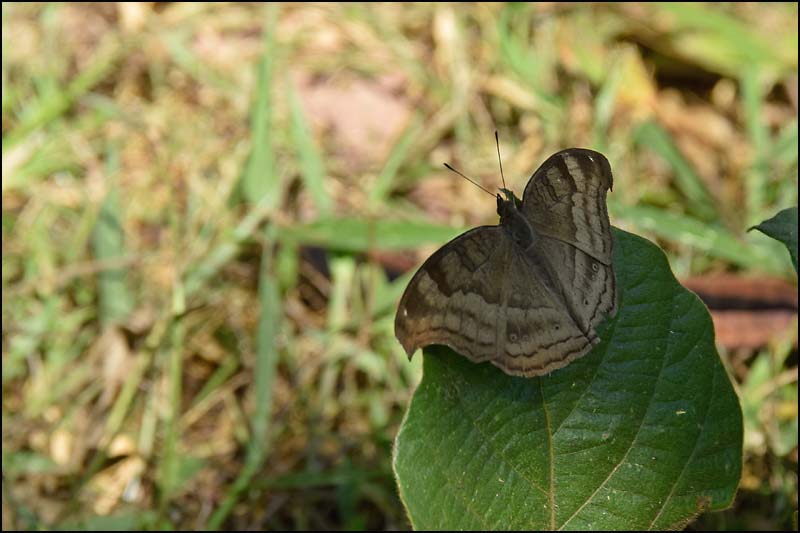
[2,2,798,530]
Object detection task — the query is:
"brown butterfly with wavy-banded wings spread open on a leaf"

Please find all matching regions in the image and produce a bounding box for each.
[395,148,616,377]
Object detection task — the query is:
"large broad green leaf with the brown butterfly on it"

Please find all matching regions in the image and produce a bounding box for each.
[394,229,742,530]
